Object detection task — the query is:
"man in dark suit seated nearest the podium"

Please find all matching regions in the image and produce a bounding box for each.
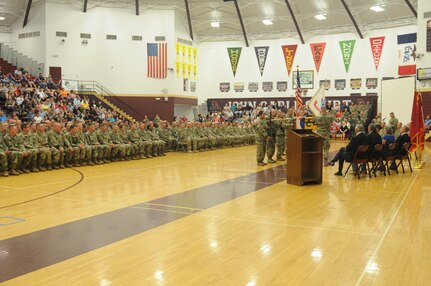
[328,124,370,176]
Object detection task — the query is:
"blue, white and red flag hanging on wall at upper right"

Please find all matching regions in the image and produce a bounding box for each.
[398,33,417,75]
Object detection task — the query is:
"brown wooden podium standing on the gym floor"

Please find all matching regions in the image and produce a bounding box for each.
[286,129,323,186]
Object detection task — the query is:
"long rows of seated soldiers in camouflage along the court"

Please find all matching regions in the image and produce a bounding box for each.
[0,121,255,176]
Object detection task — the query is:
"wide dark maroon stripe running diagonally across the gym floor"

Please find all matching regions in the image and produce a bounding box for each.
[0,166,285,283]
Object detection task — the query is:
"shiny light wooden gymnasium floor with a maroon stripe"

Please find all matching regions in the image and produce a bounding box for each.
[0,143,431,286]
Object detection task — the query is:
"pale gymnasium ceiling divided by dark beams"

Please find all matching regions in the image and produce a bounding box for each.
[0,0,418,42]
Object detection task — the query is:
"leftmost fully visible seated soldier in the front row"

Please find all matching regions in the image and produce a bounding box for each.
[3,124,25,175]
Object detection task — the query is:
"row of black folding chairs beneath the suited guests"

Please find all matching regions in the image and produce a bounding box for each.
[344,143,413,179]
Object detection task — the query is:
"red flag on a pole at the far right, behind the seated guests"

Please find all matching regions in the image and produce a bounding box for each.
[410,92,425,152]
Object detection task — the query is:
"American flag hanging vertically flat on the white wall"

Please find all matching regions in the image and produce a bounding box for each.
[147,43,168,78]
